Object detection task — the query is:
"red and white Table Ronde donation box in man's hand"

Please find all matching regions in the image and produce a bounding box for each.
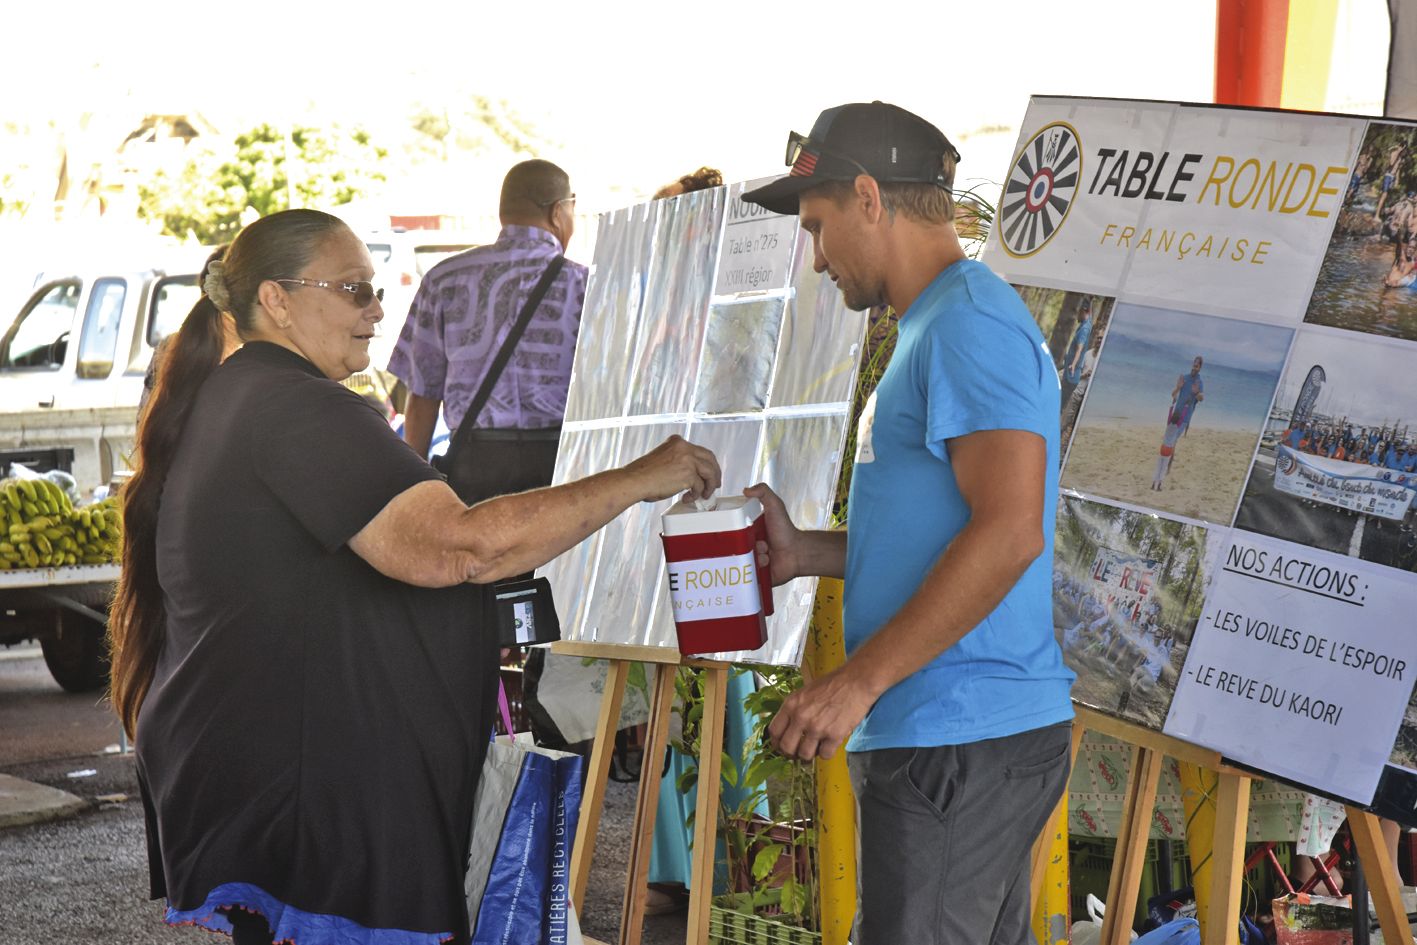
[662,496,772,656]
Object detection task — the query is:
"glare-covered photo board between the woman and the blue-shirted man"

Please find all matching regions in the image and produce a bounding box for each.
[544,181,866,666]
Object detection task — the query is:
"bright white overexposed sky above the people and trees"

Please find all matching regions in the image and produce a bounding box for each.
[0,0,1386,219]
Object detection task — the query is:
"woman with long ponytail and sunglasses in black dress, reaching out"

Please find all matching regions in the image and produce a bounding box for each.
[111,210,720,945]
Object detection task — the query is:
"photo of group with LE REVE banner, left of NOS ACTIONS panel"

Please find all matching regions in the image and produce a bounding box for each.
[1053,497,1210,730]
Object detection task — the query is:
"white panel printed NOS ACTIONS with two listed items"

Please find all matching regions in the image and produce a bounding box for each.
[1166,533,1417,803]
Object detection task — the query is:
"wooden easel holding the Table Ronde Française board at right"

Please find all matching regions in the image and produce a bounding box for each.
[1032,706,1411,945]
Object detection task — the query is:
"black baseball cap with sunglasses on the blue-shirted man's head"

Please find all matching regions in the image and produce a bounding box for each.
[743,102,959,215]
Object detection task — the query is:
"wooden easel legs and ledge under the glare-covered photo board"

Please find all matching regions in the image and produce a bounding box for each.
[551,642,728,945]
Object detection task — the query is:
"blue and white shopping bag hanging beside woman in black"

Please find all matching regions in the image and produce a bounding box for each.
[463,693,584,945]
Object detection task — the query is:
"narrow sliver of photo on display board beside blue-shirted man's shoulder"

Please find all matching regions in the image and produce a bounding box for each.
[1013,285,1117,463]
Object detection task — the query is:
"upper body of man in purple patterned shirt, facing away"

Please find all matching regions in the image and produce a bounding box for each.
[388,160,587,456]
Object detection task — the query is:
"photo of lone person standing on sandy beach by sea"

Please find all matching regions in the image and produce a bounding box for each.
[1063,303,1292,524]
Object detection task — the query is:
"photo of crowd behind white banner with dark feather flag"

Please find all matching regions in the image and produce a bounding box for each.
[1234,332,1417,571]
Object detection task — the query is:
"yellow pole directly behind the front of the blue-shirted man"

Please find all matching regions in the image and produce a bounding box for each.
[802,578,856,945]
